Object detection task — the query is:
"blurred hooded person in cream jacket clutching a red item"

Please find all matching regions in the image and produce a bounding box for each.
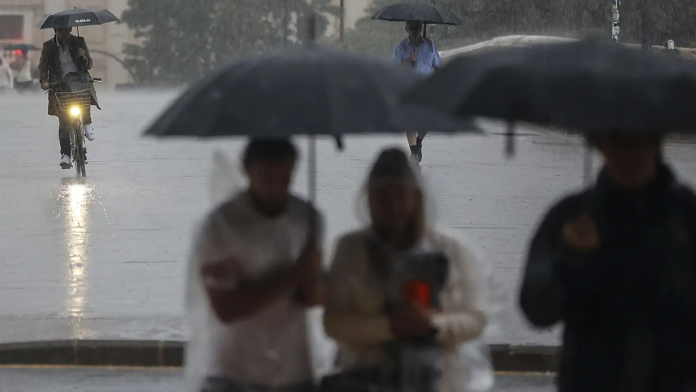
[324,148,487,392]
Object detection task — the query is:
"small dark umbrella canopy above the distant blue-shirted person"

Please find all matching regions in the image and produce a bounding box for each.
[372,1,462,25]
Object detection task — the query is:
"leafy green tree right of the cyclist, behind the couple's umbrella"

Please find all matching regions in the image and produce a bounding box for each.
[122,0,336,84]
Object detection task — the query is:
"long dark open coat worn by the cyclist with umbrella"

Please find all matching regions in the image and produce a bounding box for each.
[39,35,101,116]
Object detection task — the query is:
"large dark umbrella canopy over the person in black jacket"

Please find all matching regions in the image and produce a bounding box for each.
[404,41,696,132]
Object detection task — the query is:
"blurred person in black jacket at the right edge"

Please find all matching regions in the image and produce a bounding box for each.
[520,133,696,392]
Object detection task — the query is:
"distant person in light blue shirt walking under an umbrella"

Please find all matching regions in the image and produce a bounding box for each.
[394,20,442,163]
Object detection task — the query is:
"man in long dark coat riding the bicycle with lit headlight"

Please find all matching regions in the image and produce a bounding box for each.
[39,28,101,169]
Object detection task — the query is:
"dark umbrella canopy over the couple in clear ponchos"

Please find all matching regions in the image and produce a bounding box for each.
[145,49,476,138]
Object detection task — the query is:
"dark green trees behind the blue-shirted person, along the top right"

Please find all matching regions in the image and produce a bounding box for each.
[346,0,696,56]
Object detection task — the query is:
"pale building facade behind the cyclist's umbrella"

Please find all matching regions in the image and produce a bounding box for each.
[0,0,137,87]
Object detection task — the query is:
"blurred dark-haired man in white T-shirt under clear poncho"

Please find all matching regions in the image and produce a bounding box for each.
[186,140,324,392]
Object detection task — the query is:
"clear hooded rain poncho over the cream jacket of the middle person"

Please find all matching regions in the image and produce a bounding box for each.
[324,150,509,392]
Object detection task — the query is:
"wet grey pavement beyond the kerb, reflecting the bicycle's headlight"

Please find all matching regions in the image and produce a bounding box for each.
[0,92,696,345]
